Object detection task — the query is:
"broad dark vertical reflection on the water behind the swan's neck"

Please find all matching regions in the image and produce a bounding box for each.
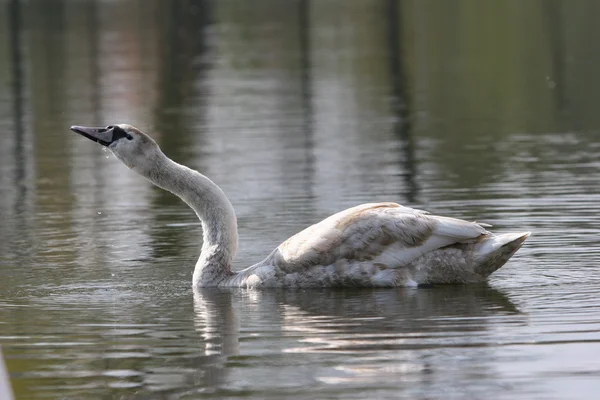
[149,0,213,257]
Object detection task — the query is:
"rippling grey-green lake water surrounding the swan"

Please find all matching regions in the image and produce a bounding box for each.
[0,0,600,399]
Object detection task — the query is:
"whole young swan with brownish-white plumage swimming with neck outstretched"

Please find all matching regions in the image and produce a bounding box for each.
[71,124,529,288]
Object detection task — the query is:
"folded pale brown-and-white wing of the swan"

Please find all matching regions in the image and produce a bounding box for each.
[265,203,489,273]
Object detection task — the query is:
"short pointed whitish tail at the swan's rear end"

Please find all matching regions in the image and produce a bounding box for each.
[474,232,531,277]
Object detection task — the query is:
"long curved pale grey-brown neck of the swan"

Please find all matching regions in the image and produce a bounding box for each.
[135,151,238,287]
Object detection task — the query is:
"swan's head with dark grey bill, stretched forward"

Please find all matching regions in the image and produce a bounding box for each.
[71,124,160,168]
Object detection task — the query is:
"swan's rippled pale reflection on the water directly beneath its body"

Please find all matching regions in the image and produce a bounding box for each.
[194,286,526,393]
